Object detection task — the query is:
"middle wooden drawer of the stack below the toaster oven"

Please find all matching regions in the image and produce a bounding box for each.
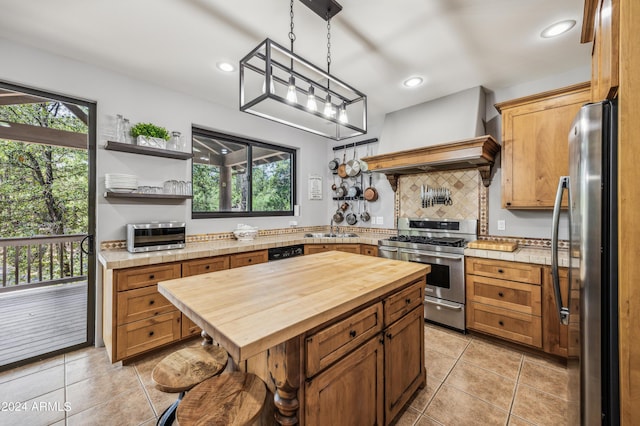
[117,285,176,325]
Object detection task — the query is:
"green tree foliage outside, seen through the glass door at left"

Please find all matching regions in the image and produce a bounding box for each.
[0,102,89,283]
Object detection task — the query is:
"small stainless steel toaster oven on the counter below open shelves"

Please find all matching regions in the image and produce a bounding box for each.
[127,222,187,253]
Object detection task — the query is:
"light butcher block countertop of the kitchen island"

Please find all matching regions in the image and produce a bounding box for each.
[158,251,430,362]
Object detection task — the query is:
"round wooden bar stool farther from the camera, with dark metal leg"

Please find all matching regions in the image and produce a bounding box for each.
[151,332,229,426]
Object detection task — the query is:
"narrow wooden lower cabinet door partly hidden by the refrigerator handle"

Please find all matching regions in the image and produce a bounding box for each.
[542,268,573,357]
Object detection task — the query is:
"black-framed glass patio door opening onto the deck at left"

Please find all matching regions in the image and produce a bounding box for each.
[0,81,96,370]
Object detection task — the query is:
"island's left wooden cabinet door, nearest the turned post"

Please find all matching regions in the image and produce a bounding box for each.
[304,336,384,426]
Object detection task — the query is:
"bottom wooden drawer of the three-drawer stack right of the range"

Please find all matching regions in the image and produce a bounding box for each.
[467,302,542,348]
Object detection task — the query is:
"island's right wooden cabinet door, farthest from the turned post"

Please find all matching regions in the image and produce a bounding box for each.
[384,306,426,423]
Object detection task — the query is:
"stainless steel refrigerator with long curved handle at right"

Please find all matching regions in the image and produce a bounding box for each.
[552,101,620,425]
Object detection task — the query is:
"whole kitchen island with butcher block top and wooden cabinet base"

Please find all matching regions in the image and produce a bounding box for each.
[158,251,430,425]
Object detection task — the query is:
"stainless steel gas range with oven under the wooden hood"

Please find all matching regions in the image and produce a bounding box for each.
[378,218,478,331]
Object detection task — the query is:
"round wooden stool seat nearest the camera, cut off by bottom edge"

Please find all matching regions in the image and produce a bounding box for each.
[177,372,267,426]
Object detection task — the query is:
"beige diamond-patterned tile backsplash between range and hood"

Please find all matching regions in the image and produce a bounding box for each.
[396,169,486,219]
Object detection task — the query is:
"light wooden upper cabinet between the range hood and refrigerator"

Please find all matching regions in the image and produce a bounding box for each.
[496,82,591,209]
